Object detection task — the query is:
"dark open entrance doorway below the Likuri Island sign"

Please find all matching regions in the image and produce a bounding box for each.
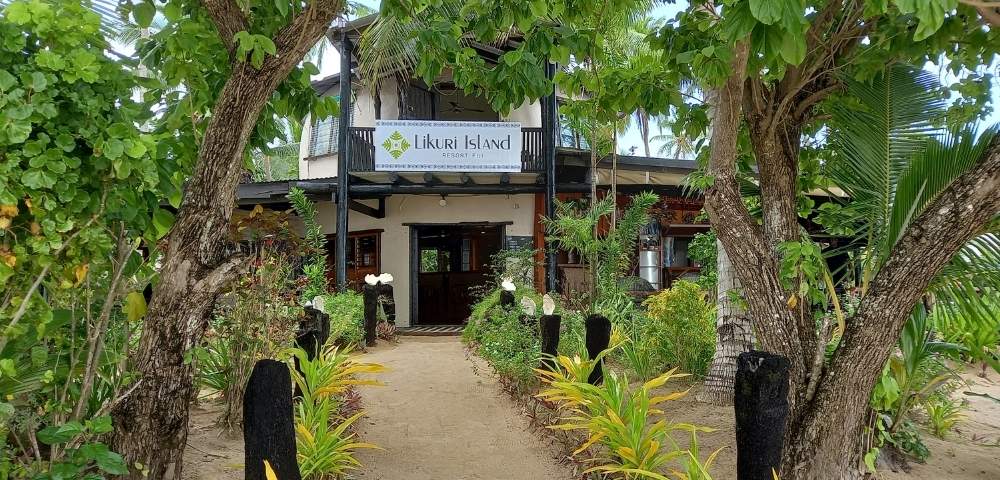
[410,223,504,325]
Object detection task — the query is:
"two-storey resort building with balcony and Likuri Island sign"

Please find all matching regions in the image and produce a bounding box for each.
[239,15,708,327]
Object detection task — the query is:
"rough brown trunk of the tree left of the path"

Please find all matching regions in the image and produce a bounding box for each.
[112,0,343,480]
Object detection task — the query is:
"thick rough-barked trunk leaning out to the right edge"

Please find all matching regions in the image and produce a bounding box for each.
[782,137,1000,480]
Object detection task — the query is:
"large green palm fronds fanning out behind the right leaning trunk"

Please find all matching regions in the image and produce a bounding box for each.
[829,66,1000,371]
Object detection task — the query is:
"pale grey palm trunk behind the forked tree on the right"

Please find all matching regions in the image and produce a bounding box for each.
[698,240,753,405]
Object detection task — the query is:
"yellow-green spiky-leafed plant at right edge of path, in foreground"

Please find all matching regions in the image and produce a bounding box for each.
[537,356,714,480]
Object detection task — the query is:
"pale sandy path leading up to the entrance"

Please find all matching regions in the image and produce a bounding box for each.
[356,337,572,480]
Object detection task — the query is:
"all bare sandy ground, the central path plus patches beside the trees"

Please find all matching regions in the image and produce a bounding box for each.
[184,337,1000,480]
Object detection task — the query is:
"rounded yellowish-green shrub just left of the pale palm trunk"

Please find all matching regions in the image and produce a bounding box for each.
[641,280,715,376]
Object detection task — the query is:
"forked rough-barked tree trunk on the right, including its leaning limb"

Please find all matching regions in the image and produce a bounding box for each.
[705,31,1000,480]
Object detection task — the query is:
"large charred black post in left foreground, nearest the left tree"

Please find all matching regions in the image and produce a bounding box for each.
[243,359,302,480]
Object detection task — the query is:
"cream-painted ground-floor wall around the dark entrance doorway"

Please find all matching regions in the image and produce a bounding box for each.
[317,194,535,326]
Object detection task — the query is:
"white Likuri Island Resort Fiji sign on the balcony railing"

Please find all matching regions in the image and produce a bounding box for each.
[375,120,521,172]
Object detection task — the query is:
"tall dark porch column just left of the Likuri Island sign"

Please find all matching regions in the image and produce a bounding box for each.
[336,29,351,290]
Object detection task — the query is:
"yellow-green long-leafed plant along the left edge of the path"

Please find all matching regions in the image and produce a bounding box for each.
[292,346,385,480]
